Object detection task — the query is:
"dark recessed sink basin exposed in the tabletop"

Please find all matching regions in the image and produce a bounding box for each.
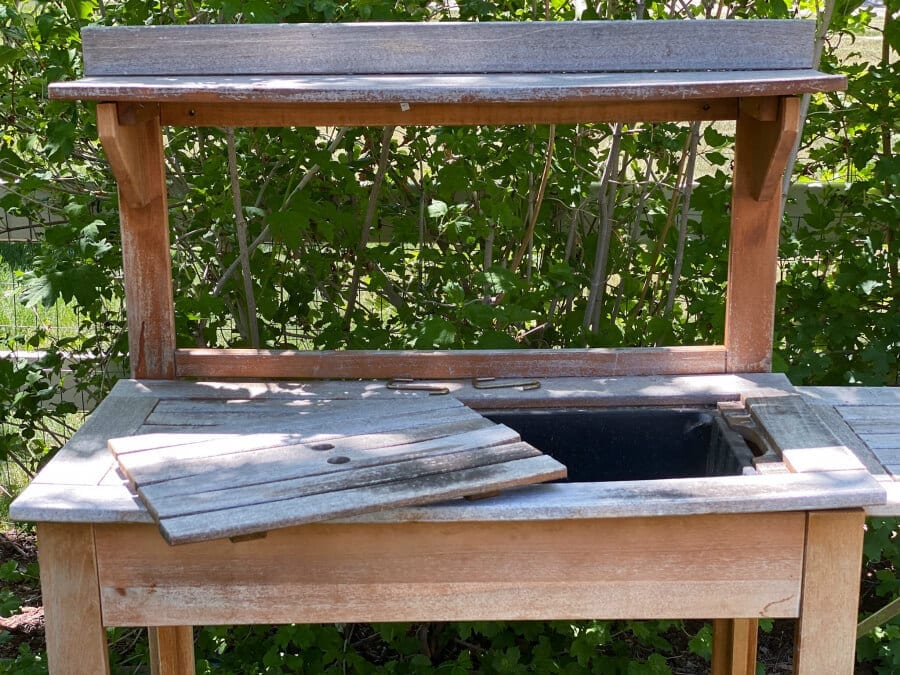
[483,408,753,483]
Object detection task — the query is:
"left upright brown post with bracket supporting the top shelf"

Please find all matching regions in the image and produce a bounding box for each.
[97,103,175,379]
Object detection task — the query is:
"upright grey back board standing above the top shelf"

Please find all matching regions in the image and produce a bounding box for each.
[82,20,815,77]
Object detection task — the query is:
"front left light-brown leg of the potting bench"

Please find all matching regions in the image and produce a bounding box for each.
[38,523,109,675]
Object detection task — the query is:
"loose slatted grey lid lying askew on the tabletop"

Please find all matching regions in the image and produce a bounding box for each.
[109,396,566,544]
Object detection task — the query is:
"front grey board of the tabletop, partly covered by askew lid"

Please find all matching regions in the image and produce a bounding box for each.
[10,471,884,523]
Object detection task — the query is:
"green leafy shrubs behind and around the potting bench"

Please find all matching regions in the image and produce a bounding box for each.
[0,0,900,673]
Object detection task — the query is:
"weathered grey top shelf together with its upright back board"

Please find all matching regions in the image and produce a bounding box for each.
[50,20,846,109]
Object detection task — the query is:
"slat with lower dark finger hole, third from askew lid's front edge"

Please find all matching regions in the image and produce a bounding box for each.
[119,419,519,499]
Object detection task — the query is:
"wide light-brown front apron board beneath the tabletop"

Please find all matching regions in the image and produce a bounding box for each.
[97,516,805,625]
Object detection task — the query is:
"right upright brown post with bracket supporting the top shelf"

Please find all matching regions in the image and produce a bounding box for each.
[725,97,799,373]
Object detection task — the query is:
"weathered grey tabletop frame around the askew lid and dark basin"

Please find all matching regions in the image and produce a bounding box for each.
[10,374,888,523]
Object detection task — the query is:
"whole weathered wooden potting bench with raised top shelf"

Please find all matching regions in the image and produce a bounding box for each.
[11,21,892,675]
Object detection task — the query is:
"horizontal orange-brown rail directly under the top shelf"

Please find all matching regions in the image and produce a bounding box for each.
[158,99,740,127]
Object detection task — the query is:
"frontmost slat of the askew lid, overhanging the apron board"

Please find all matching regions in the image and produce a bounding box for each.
[159,455,566,544]
